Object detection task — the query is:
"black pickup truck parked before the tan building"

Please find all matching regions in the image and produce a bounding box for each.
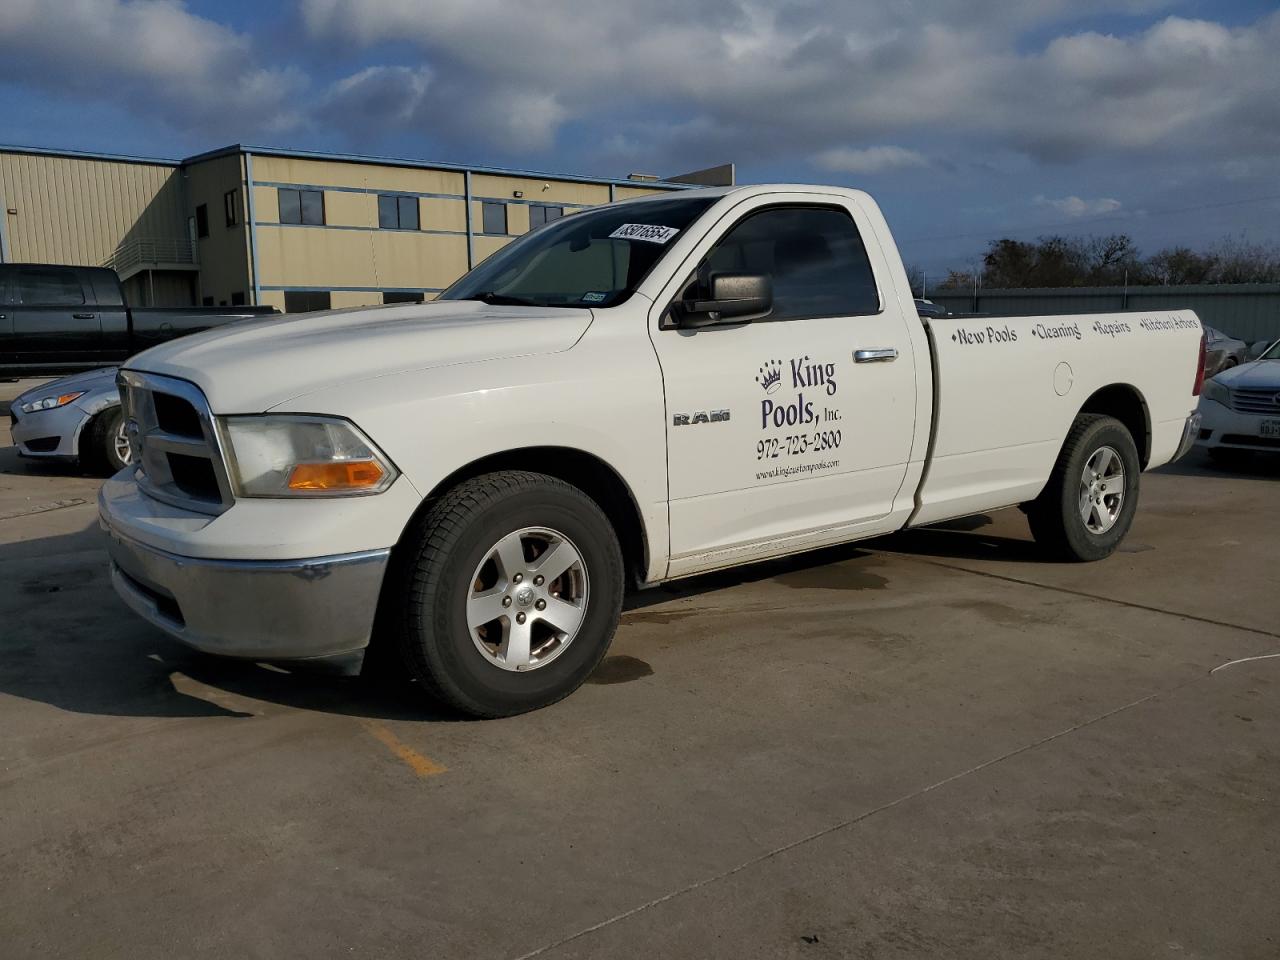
[0,264,275,375]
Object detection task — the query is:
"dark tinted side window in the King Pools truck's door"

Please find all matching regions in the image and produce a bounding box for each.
[686,207,881,320]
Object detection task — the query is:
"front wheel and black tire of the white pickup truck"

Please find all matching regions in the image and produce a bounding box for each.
[384,471,623,718]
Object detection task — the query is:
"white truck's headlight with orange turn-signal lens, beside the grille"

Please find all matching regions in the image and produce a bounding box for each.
[219,416,397,497]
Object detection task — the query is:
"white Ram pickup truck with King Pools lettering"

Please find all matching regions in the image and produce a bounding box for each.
[99,186,1203,717]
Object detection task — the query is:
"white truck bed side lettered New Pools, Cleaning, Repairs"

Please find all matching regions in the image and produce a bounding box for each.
[910,310,1202,526]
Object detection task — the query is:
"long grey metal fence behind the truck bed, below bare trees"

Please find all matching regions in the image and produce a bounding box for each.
[929,283,1280,343]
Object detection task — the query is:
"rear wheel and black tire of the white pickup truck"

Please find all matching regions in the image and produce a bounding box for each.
[1027,413,1140,562]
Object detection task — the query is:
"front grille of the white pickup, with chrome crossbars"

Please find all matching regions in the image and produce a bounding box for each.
[116,370,232,515]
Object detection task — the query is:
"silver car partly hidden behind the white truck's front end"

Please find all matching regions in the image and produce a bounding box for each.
[9,366,131,474]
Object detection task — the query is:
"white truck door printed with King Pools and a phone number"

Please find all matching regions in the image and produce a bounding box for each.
[652,195,919,575]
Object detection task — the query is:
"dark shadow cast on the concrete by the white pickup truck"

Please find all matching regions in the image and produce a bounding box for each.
[0,517,1034,722]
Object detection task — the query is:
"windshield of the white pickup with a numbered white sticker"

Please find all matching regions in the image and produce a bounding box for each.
[439,196,718,307]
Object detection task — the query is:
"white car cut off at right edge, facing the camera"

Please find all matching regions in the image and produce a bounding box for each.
[1199,342,1280,460]
